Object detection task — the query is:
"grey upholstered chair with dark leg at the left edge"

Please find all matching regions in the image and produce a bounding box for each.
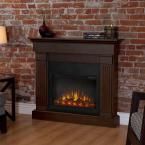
[0,92,7,133]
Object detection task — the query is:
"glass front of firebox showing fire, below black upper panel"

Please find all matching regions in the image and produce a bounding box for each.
[49,74,99,115]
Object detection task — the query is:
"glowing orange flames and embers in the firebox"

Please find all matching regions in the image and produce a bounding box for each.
[55,91,95,108]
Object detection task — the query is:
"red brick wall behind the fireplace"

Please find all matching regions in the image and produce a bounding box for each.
[0,0,145,111]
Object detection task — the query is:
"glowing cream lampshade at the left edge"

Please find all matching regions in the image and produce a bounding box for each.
[0,26,7,44]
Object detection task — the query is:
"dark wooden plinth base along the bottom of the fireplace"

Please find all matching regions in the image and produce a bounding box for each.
[32,110,120,127]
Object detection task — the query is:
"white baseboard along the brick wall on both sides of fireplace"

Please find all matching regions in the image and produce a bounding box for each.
[6,103,129,125]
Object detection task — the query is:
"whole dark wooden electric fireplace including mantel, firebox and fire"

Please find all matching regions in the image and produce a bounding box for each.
[30,38,121,127]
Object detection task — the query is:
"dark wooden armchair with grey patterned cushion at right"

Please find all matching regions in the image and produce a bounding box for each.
[126,92,145,145]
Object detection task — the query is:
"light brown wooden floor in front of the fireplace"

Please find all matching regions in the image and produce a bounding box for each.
[0,115,127,145]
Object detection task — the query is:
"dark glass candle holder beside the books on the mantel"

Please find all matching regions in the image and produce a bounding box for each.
[104,25,118,39]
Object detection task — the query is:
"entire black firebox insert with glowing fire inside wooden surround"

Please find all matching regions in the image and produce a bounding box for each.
[48,62,100,115]
